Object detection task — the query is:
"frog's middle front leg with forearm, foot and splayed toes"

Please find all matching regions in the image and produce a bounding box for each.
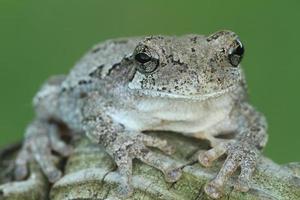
[84,115,181,196]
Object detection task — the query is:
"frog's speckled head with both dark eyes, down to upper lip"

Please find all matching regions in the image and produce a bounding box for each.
[129,31,244,100]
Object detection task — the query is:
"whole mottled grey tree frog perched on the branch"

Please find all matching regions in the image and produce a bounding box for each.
[10,31,267,198]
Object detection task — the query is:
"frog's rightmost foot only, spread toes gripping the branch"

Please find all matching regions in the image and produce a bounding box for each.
[199,141,259,199]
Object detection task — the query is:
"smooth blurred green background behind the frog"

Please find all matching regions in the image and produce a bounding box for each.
[0,0,300,163]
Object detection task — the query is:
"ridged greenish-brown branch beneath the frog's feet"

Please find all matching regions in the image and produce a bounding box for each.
[0,133,300,200]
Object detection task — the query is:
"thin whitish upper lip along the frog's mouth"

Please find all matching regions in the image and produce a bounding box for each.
[133,85,238,101]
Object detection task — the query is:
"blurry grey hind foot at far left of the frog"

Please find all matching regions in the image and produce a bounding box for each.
[15,120,72,183]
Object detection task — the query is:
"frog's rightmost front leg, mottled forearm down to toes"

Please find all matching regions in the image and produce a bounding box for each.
[199,103,267,198]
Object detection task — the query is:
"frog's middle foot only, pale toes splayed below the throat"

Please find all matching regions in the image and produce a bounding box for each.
[107,134,182,197]
